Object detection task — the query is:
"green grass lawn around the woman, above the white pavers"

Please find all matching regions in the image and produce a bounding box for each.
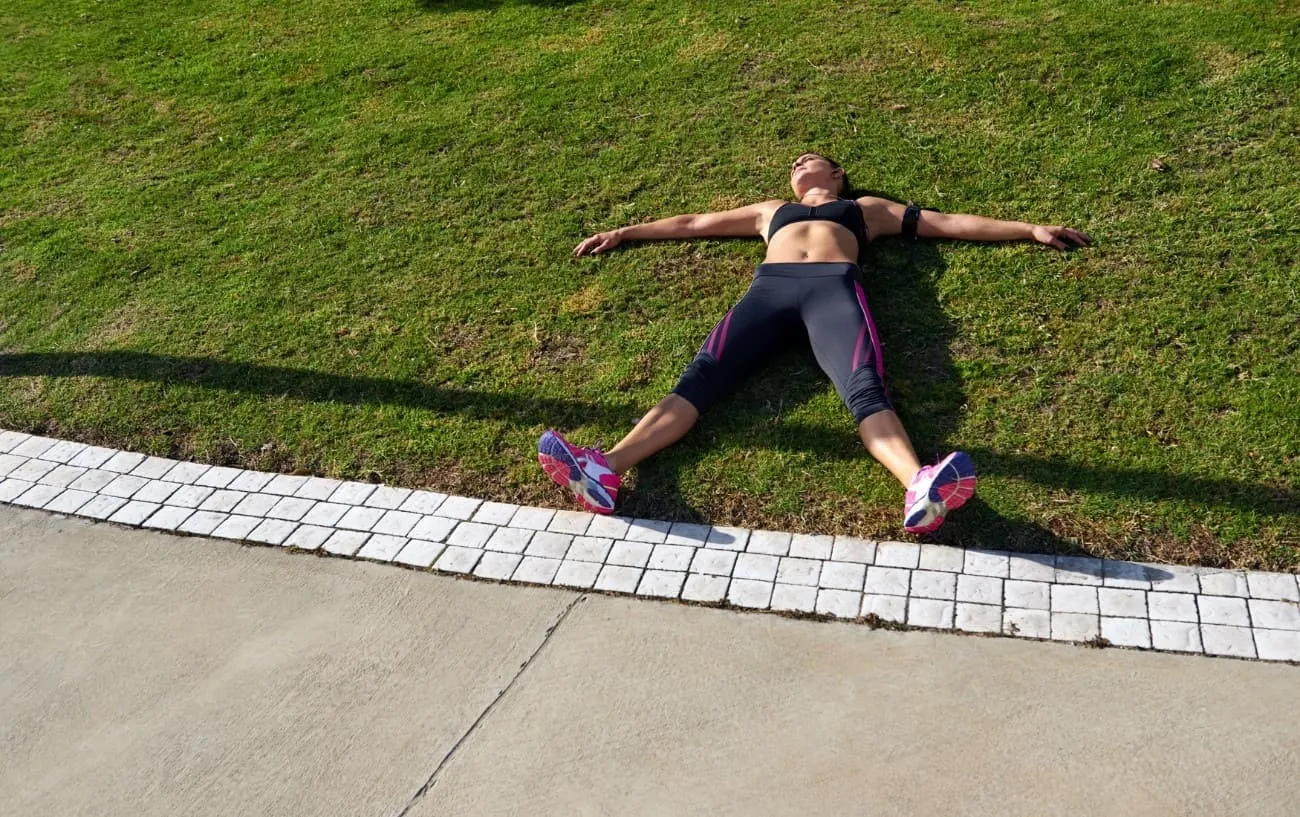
[0,0,1300,569]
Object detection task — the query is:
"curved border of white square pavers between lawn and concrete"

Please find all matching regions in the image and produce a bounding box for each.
[0,431,1300,663]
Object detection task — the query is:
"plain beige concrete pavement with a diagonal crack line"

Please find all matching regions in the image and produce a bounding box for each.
[0,507,1300,817]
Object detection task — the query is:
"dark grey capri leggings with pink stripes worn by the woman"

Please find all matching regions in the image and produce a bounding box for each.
[672,263,892,423]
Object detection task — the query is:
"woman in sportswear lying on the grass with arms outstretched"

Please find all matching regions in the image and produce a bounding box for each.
[537,154,1092,533]
